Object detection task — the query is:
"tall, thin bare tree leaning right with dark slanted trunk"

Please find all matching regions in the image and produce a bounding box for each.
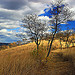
[40,0,73,57]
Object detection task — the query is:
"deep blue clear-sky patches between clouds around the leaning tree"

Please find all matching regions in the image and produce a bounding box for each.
[39,4,75,31]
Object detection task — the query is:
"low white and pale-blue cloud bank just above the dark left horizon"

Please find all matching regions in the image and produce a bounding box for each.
[0,29,21,43]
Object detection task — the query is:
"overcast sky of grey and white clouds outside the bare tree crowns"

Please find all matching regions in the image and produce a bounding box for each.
[0,0,75,43]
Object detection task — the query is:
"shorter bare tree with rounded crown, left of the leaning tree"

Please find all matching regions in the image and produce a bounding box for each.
[22,15,47,55]
